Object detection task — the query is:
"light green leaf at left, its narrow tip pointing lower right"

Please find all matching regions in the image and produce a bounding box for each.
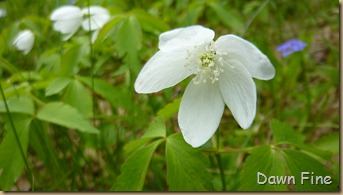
[37,102,99,133]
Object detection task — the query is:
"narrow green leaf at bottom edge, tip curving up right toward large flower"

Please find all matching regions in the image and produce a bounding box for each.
[111,140,162,191]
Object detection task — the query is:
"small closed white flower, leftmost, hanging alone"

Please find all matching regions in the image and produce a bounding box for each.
[13,30,35,55]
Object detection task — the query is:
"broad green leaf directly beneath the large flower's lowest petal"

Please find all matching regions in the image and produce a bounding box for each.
[166,133,212,191]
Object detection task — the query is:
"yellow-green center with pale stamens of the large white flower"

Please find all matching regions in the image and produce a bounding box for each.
[193,42,226,84]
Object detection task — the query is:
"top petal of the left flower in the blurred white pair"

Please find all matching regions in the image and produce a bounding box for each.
[50,5,83,21]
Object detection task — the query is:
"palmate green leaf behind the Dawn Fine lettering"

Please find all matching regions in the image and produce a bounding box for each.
[239,145,339,192]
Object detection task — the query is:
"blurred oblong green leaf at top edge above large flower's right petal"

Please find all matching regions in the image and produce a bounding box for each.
[208,2,244,30]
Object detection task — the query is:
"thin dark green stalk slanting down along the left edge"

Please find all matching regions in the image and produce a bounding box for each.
[0,82,34,190]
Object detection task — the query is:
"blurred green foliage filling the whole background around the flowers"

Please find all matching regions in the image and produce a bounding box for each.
[0,0,339,191]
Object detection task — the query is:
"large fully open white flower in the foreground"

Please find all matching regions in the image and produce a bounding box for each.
[135,26,275,147]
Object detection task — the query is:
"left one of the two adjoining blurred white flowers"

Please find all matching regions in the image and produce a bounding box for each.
[50,5,83,41]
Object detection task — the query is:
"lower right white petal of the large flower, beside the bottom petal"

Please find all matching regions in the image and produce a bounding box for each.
[219,60,256,129]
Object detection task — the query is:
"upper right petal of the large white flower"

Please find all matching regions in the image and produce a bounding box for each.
[215,35,275,80]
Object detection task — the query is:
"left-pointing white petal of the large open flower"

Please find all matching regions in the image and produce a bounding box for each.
[135,51,194,93]
